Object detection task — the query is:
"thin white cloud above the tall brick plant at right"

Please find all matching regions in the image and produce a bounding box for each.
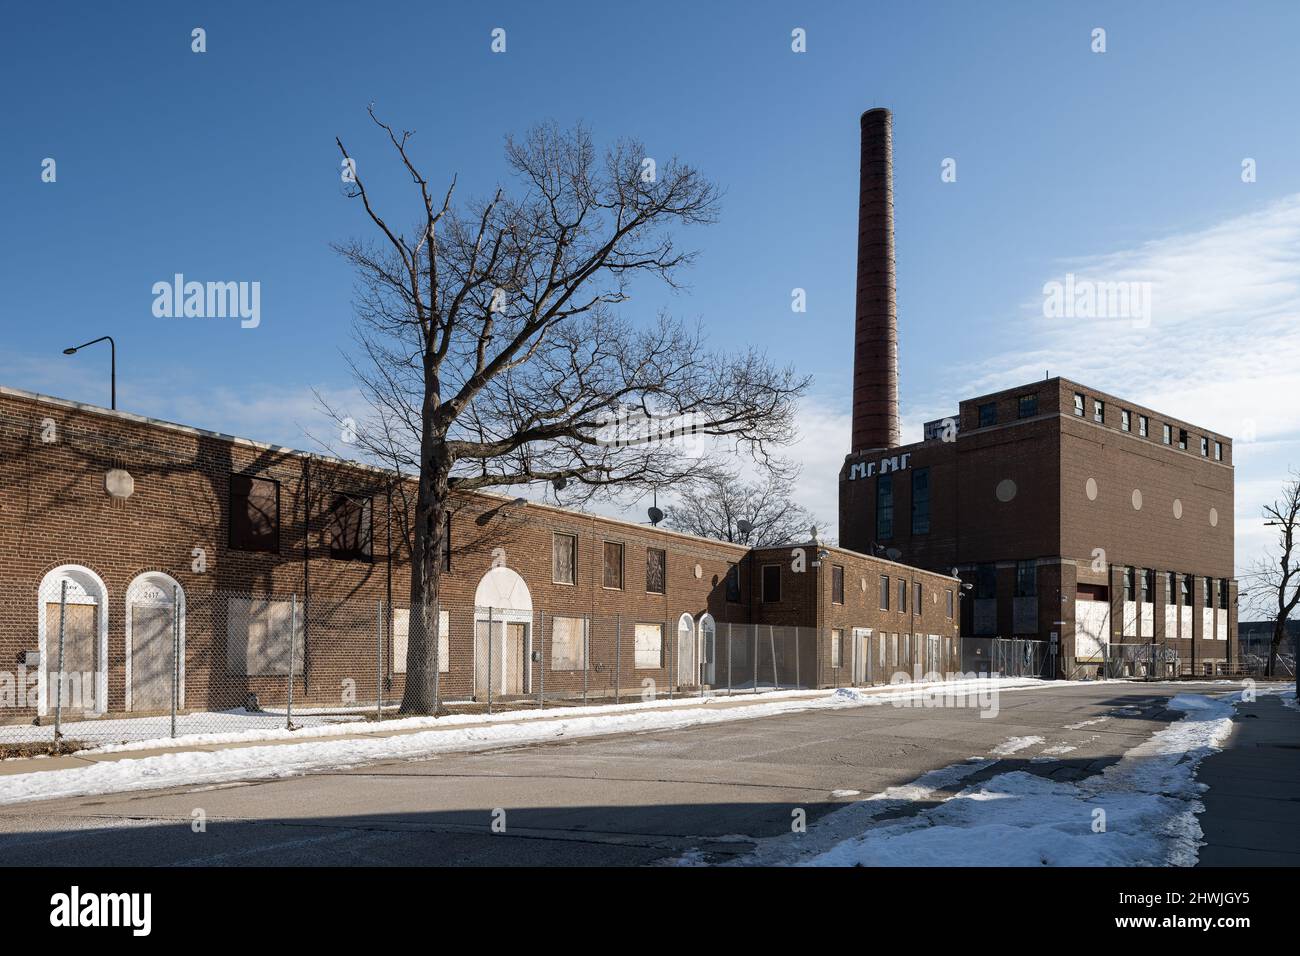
[905,194,1300,580]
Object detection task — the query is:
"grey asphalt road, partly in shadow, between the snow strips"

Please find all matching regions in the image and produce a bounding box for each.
[0,683,1231,866]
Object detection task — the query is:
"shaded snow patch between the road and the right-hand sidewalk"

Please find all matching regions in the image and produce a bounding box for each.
[794,695,1240,866]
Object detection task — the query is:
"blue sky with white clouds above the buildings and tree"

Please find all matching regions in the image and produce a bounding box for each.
[0,1,1300,582]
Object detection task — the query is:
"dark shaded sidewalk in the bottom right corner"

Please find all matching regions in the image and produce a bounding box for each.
[1196,695,1300,866]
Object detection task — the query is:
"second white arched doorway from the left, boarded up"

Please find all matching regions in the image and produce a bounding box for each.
[126,571,185,711]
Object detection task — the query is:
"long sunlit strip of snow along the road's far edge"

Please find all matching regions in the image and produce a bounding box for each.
[0,678,1047,804]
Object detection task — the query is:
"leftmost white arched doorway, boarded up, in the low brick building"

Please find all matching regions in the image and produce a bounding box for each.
[36,564,108,715]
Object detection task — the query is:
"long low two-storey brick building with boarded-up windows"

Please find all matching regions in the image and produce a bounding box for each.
[0,389,958,722]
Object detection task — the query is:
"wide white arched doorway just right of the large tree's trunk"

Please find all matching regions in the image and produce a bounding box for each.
[475,567,533,700]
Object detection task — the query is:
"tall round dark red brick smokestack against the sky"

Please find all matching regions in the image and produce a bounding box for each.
[850,109,902,451]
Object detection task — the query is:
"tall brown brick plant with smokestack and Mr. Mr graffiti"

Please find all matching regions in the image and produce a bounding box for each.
[840,109,1236,676]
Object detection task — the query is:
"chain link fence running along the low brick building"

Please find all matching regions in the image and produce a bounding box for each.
[0,582,957,754]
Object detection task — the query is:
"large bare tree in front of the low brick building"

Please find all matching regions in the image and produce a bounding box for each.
[326,108,807,713]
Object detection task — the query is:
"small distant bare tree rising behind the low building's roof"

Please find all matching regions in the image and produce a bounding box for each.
[664,473,816,548]
